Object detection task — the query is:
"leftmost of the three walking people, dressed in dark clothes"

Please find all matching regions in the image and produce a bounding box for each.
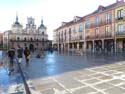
[8,47,15,75]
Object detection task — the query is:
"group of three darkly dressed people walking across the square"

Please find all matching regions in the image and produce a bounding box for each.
[7,46,30,75]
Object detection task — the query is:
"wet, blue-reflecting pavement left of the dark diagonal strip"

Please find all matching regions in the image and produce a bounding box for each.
[0,51,25,94]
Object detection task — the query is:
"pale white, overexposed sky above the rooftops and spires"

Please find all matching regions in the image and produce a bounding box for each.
[0,0,116,39]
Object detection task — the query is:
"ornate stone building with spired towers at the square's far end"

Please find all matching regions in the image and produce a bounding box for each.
[4,16,50,51]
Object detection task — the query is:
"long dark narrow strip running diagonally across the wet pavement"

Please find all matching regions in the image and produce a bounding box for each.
[16,58,31,94]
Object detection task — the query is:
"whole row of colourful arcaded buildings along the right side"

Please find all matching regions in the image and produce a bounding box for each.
[54,0,125,52]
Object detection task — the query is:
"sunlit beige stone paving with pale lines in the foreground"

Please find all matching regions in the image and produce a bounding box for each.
[29,61,125,94]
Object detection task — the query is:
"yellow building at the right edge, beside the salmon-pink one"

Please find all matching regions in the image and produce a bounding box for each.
[115,0,125,52]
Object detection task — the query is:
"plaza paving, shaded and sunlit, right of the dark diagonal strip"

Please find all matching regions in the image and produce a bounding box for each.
[1,53,125,94]
